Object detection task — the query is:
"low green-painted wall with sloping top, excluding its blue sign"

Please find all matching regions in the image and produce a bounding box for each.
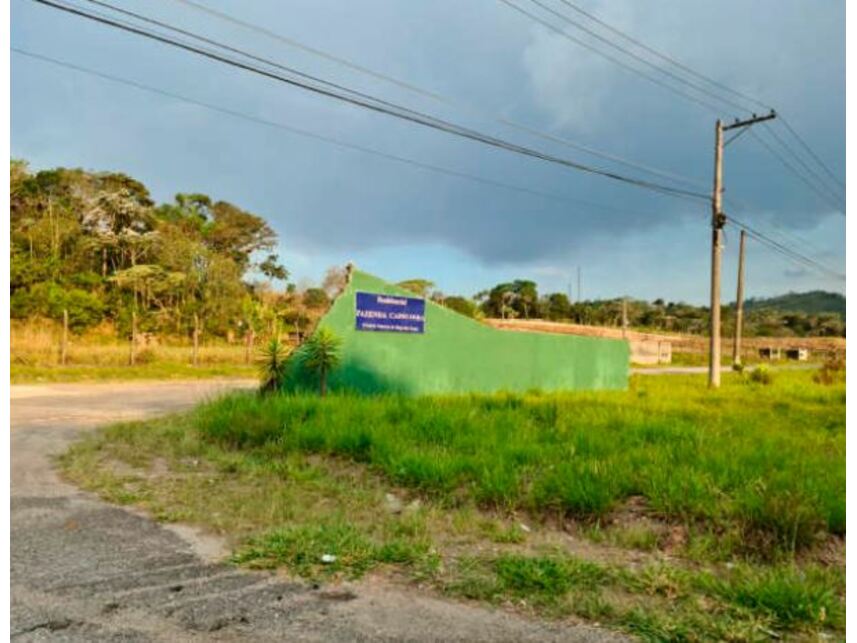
[284,271,629,395]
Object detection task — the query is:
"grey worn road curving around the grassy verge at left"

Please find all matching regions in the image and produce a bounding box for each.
[11,381,620,641]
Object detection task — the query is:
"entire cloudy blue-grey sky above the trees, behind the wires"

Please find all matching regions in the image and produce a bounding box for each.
[11,0,845,303]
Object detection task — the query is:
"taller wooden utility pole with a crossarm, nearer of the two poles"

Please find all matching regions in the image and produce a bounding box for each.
[708,110,777,388]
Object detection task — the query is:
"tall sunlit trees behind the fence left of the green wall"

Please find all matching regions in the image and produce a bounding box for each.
[10,160,342,337]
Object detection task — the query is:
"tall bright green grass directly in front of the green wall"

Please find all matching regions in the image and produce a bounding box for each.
[195,372,845,556]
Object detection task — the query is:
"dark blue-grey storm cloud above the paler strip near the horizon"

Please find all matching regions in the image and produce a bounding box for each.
[13,0,844,274]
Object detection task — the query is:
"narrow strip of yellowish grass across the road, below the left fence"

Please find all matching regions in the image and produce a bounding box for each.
[10,362,259,384]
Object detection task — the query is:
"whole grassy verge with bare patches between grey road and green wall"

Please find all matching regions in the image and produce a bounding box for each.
[62,371,845,640]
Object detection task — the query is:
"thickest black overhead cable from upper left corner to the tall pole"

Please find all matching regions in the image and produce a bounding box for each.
[28,0,708,200]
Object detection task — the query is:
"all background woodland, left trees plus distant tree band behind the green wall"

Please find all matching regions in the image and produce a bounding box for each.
[10,160,845,337]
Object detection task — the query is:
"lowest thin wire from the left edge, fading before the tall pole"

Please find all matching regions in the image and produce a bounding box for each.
[10,47,676,217]
